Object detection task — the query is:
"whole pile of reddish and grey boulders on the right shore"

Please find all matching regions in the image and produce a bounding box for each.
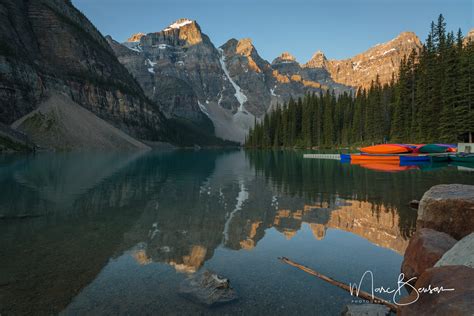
[397,184,474,315]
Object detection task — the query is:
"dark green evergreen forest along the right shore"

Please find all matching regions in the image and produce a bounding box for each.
[246,15,474,148]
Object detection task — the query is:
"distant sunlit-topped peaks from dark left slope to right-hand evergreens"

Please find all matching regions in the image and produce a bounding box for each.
[107,19,421,142]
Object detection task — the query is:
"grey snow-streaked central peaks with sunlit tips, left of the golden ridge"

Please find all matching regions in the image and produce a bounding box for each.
[107,19,351,142]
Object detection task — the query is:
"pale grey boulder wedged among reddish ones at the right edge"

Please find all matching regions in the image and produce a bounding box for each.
[435,233,474,268]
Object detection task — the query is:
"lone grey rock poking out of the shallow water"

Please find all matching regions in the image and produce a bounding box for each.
[179,270,237,307]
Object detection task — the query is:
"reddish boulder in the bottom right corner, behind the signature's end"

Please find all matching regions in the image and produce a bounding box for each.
[397,266,474,316]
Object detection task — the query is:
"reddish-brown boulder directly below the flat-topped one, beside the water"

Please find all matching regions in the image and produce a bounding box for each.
[402,228,456,283]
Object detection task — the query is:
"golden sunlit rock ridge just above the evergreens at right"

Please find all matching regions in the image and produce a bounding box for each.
[304,32,422,88]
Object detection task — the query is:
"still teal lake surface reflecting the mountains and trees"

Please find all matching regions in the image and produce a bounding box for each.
[0,150,474,315]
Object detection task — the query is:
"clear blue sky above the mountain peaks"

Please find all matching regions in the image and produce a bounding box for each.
[72,0,474,63]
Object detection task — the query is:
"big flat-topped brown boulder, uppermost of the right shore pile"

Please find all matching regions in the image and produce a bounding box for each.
[417,184,474,239]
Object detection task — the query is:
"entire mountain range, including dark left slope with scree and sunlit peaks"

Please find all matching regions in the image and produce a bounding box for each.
[0,0,430,149]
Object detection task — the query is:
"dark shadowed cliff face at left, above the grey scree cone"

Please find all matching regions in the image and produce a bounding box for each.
[0,0,170,140]
